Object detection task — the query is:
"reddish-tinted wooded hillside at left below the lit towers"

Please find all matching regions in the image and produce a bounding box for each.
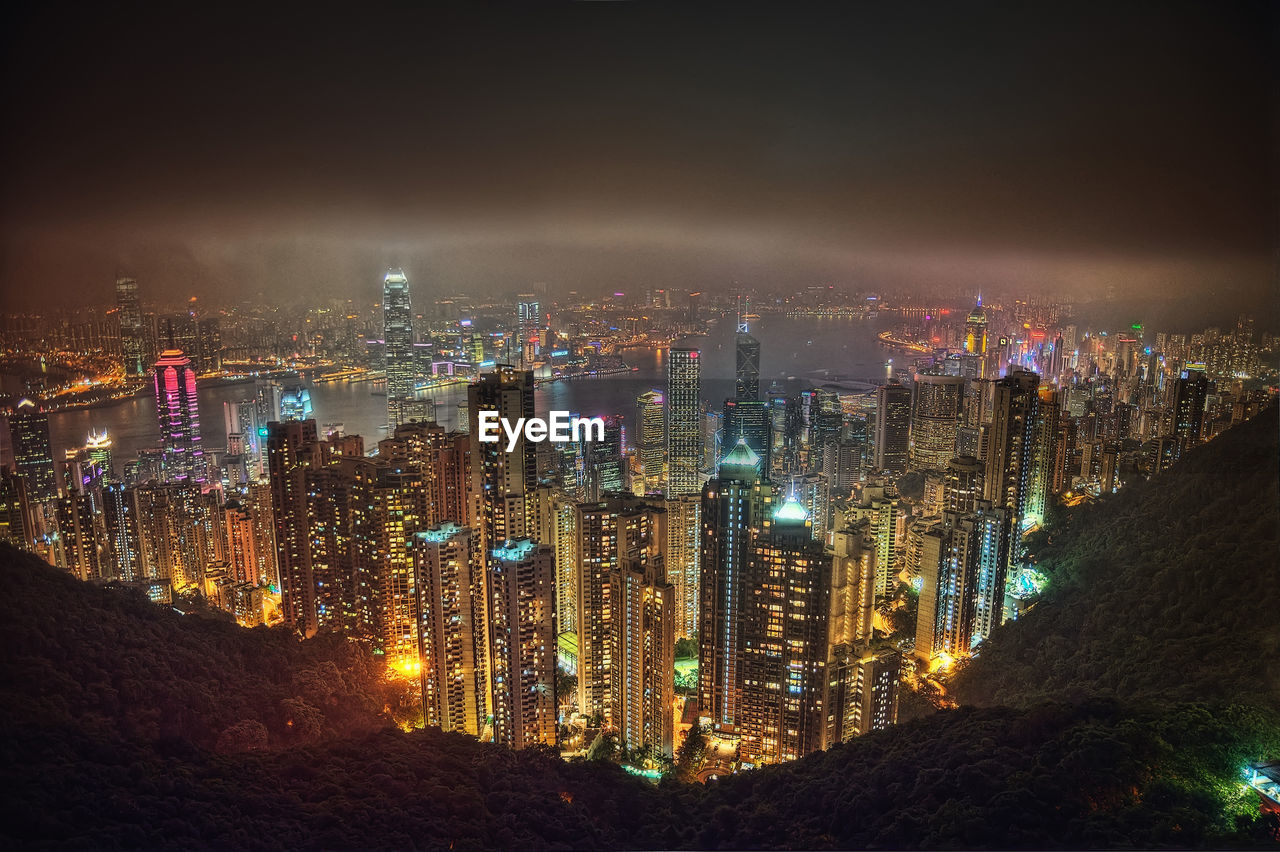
[0,548,389,750]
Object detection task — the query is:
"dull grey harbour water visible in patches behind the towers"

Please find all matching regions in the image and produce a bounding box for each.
[49,316,888,465]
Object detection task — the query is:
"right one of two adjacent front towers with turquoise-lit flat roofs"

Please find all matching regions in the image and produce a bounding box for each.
[486,539,556,748]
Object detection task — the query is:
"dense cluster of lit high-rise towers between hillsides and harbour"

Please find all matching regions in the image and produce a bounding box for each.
[0,280,1264,765]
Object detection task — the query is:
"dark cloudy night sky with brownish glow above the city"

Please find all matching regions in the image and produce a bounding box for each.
[0,3,1277,310]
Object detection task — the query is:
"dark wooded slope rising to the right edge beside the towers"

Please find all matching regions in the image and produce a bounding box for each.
[954,407,1280,709]
